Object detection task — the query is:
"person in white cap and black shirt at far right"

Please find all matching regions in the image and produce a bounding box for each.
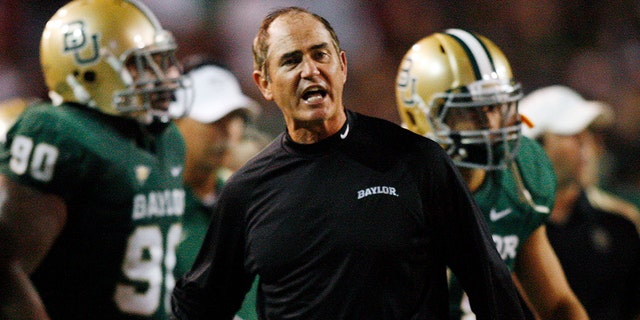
[520,85,640,320]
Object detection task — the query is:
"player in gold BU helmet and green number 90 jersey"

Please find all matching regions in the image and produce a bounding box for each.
[0,0,188,319]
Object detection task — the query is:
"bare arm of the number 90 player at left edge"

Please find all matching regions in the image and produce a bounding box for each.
[0,175,67,320]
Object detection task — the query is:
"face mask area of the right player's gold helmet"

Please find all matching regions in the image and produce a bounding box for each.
[427,80,522,170]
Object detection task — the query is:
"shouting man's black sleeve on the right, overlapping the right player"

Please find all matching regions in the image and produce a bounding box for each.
[429,148,525,320]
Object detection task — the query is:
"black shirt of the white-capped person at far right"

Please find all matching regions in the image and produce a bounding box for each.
[547,190,640,320]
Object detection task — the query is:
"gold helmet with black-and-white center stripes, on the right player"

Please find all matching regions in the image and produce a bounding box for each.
[396,29,522,170]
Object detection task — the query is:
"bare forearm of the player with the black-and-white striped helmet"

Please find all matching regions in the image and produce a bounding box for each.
[515,225,589,320]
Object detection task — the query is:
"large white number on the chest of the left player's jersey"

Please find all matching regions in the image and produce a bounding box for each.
[114,223,182,316]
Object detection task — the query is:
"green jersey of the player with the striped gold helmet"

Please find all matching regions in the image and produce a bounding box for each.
[449,137,556,320]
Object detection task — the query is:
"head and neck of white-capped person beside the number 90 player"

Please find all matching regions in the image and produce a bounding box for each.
[172,58,260,211]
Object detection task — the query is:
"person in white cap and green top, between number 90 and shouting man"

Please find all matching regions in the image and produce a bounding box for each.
[175,56,261,319]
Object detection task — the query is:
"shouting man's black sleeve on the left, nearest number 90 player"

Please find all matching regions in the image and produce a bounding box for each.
[171,179,254,320]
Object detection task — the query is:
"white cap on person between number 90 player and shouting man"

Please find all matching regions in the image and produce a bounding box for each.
[176,64,260,123]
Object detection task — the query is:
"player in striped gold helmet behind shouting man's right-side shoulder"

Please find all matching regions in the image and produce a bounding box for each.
[396,29,587,319]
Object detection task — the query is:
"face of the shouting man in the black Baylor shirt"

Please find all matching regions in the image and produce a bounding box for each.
[257,14,347,123]
